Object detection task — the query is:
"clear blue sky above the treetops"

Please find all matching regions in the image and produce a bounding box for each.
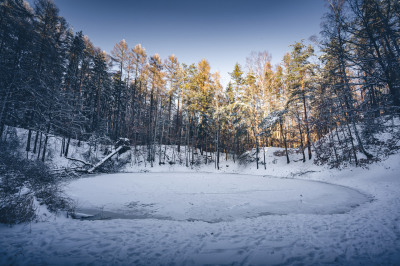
[28,0,326,85]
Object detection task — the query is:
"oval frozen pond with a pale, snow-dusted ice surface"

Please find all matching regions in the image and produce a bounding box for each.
[67,173,368,223]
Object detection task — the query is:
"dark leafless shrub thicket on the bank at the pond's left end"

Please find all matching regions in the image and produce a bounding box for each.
[0,137,75,226]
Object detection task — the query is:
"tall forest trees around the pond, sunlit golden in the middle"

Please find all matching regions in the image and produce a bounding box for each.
[0,0,400,166]
